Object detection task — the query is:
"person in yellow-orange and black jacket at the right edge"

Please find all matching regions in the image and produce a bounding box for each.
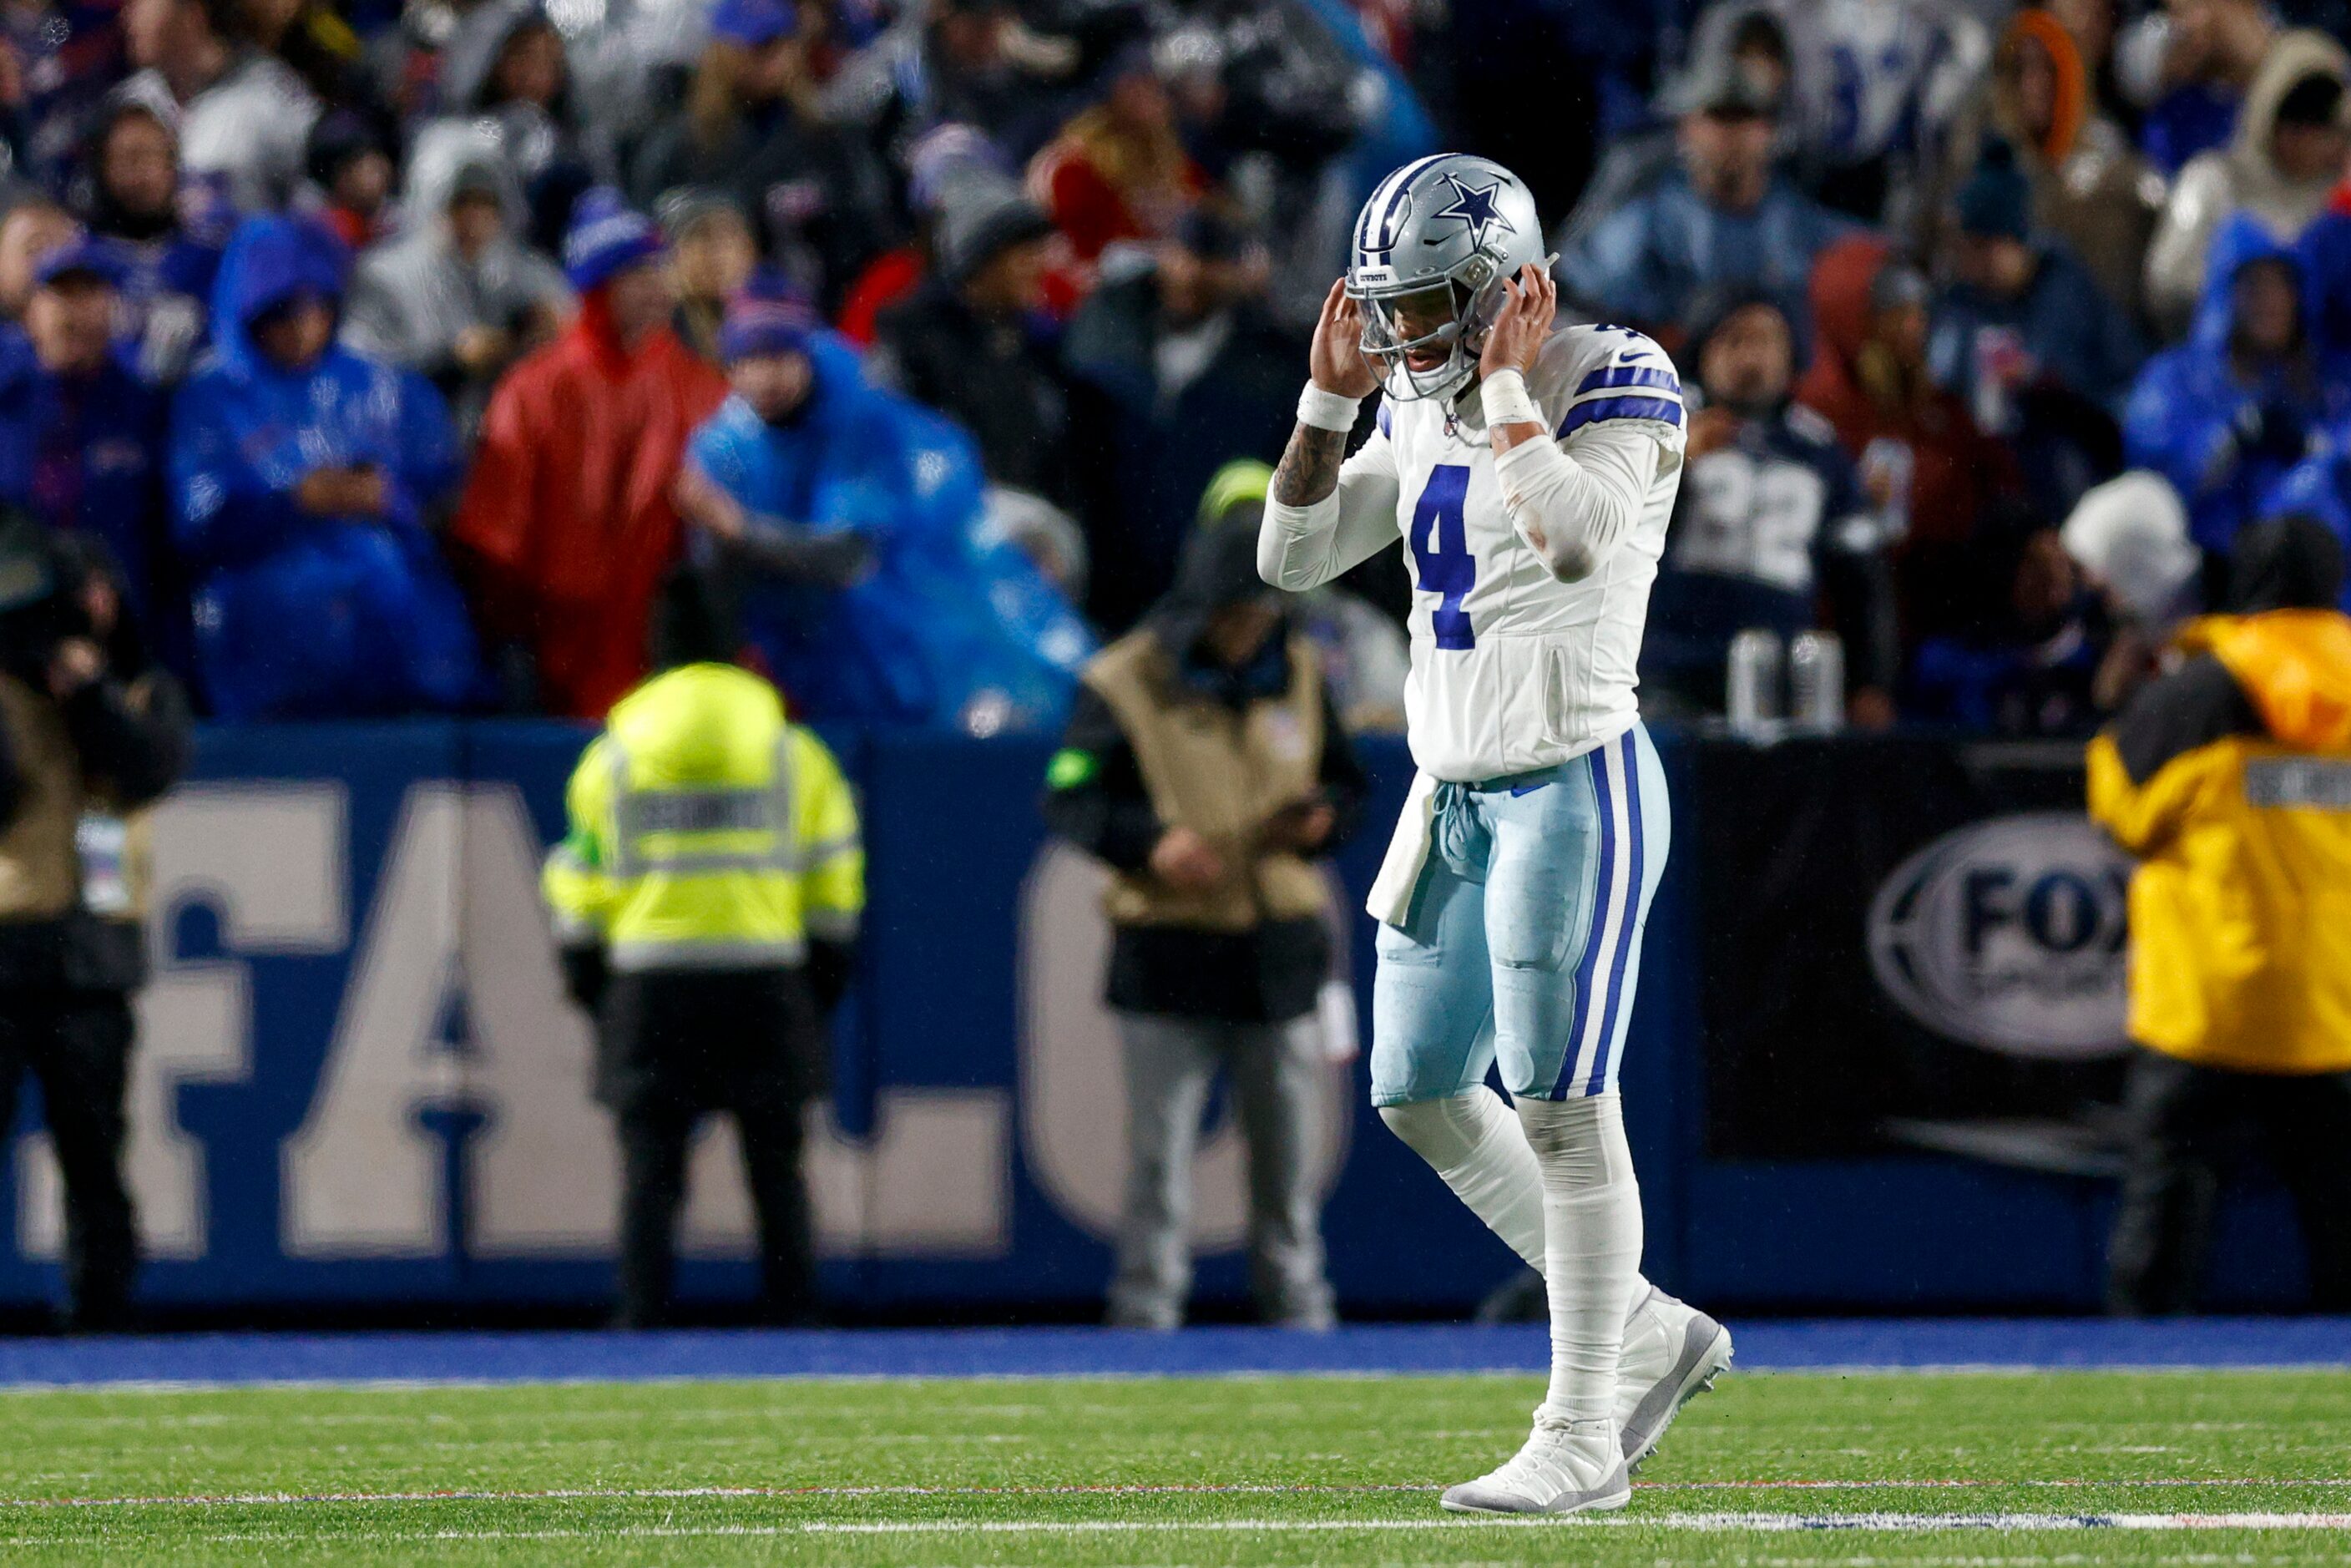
[2090,517,2351,1314]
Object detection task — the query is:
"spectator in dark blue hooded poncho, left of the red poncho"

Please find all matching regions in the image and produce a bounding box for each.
[169,219,478,720]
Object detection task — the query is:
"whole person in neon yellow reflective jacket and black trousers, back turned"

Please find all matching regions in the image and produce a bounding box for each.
[543,574,865,1328]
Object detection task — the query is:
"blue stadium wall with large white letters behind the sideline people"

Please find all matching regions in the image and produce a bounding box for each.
[0,724,2299,1317]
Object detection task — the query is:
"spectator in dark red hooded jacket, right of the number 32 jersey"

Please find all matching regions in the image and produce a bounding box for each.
[1796,235,2020,642]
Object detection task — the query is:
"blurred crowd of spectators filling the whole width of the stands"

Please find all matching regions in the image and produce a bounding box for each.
[0,0,2351,733]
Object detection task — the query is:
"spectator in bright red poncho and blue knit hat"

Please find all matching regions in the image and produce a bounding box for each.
[452,190,726,720]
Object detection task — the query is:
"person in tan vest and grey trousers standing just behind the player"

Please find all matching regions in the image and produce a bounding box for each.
[1044,491,1363,1328]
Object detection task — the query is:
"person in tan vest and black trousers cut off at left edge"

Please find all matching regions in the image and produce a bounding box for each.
[0,515,188,1331]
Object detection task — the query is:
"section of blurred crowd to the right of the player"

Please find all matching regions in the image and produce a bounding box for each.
[1556,0,2351,736]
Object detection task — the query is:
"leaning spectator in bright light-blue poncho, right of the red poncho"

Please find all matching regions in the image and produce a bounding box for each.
[680,282,1093,733]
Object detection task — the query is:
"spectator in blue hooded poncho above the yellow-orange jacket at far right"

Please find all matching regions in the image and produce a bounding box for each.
[2123,214,2351,566]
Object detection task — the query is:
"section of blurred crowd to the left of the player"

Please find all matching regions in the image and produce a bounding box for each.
[0,0,1432,733]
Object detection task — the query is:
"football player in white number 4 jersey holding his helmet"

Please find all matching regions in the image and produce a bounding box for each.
[1258,153,1731,1514]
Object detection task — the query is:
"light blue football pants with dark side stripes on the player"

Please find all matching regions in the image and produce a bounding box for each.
[1371,724,1671,1105]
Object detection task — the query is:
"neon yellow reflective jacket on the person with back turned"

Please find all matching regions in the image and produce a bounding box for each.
[543,665,865,971]
